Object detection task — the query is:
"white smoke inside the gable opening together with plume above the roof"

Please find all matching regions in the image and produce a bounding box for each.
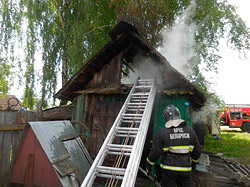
[122,0,197,84]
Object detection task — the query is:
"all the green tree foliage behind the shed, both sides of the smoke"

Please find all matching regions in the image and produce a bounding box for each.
[0,0,250,108]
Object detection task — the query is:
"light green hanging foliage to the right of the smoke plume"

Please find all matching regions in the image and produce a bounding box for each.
[186,0,250,93]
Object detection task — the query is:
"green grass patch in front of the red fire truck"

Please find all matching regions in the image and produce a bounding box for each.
[204,132,250,164]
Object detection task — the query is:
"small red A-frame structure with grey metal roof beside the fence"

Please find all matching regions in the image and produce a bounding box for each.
[6,121,93,187]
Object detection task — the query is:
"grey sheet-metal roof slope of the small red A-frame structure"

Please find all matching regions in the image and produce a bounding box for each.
[29,121,93,186]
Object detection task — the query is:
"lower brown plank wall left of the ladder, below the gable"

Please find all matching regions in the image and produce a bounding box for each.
[83,94,126,158]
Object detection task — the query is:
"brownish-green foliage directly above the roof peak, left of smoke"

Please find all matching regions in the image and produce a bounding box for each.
[111,0,188,47]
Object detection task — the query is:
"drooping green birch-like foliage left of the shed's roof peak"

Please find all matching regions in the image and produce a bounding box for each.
[0,0,114,109]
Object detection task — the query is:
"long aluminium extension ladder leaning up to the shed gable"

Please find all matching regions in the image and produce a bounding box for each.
[81,79,156,187]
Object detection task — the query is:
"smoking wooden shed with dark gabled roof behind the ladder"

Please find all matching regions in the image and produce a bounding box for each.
[55,21,206,161]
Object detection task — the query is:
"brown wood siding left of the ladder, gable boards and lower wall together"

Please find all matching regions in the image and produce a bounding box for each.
[73,53,125,158]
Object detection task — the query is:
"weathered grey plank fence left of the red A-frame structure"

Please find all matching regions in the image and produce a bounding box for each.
[0,111,36,186]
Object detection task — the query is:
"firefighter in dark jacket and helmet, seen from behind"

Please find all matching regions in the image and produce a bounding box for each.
[146,105,201,187]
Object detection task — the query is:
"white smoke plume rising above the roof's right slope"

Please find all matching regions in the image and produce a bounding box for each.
[158,0,198,76]
